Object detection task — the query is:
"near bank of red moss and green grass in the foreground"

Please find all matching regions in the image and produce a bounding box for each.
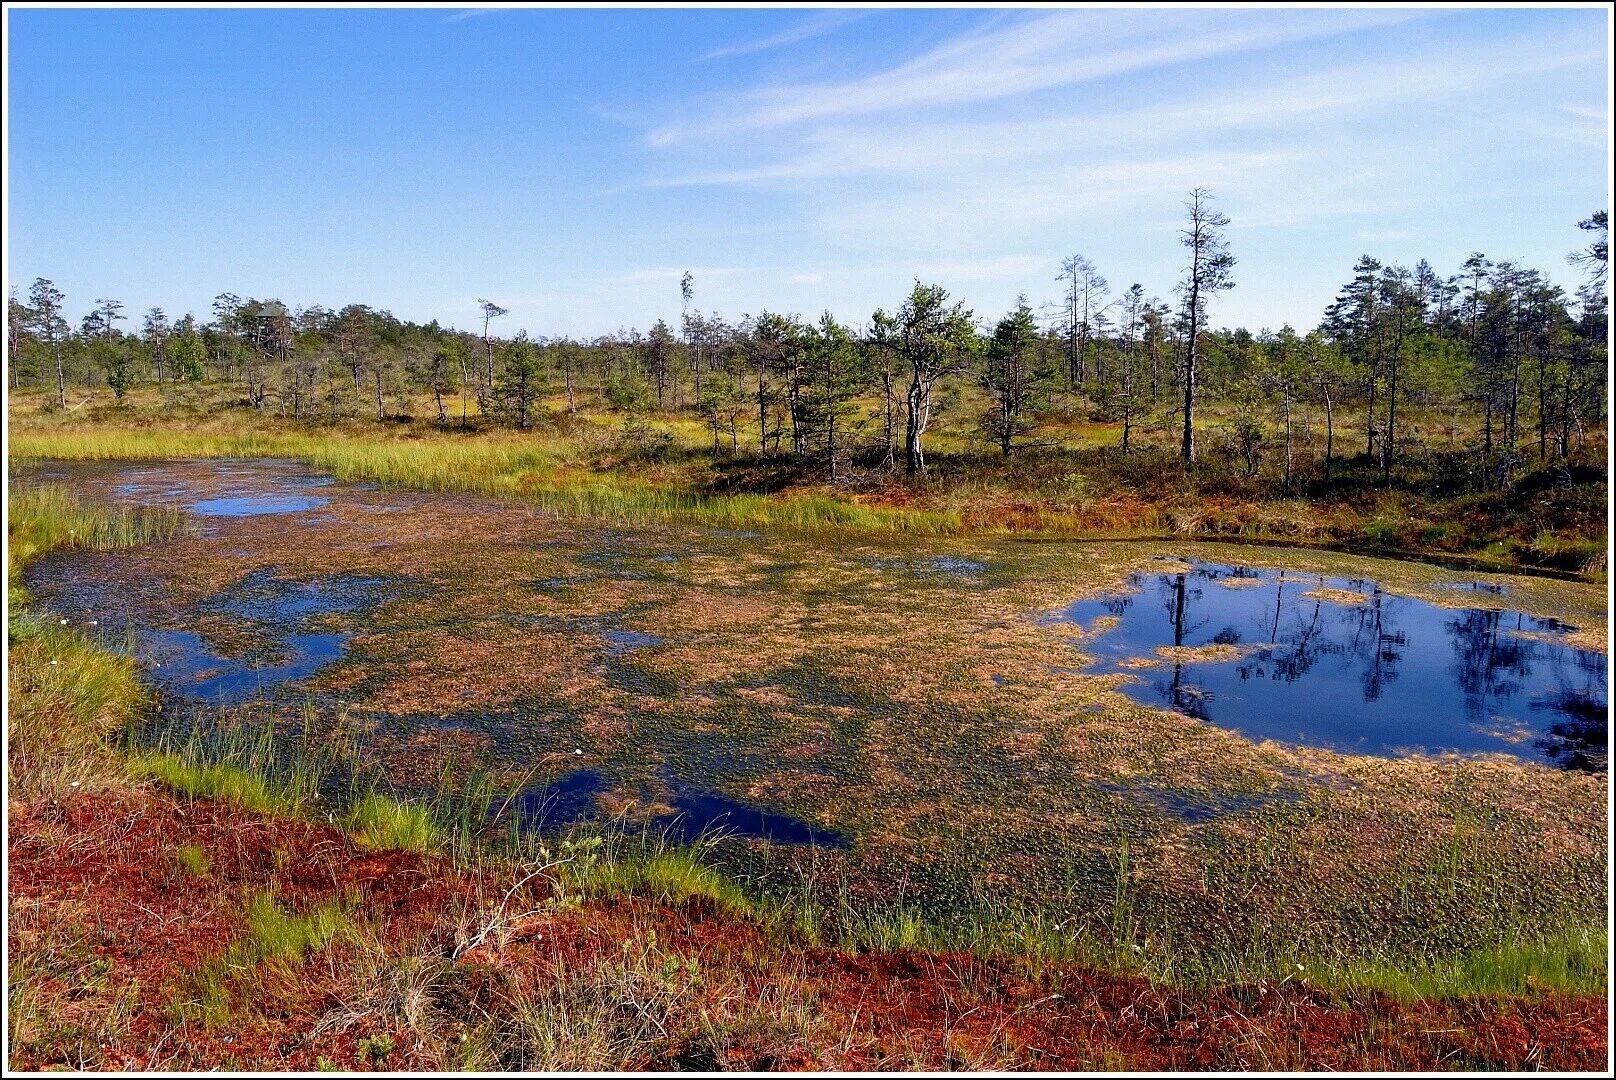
[8,485,1606,1069]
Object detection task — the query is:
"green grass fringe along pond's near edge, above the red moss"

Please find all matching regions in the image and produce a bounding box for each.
[8,472,1608,1012]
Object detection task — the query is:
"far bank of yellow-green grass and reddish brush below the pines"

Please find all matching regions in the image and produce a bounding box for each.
[11,386,1606,579]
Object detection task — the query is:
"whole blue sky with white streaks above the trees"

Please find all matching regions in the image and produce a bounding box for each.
[6,8,1608,336]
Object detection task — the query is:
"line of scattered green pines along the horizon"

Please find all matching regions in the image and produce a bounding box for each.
[6,189,1610,487]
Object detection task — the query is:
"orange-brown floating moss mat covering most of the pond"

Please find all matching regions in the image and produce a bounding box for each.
[12,464,1606,975]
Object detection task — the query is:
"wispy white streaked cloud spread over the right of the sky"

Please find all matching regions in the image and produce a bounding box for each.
[584,10,1608,333]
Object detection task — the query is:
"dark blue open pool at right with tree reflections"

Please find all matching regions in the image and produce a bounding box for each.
[1062,561,1608,770]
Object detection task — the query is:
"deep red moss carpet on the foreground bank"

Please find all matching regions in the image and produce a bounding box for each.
[10,791,1608,1070]
